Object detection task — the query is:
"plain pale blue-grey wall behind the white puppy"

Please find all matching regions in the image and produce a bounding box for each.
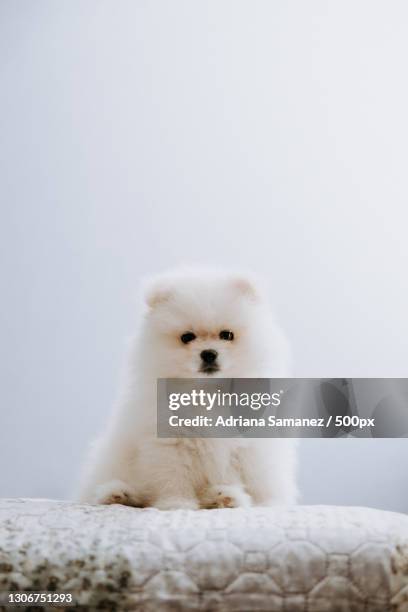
[0,0,408,511]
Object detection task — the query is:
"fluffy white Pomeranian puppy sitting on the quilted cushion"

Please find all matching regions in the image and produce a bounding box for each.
[80,270,296,510]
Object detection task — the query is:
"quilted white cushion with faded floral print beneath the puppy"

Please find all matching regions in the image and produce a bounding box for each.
[0,499,408,612]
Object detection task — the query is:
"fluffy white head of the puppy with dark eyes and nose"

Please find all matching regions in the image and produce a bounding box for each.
[140,271,290,378]
